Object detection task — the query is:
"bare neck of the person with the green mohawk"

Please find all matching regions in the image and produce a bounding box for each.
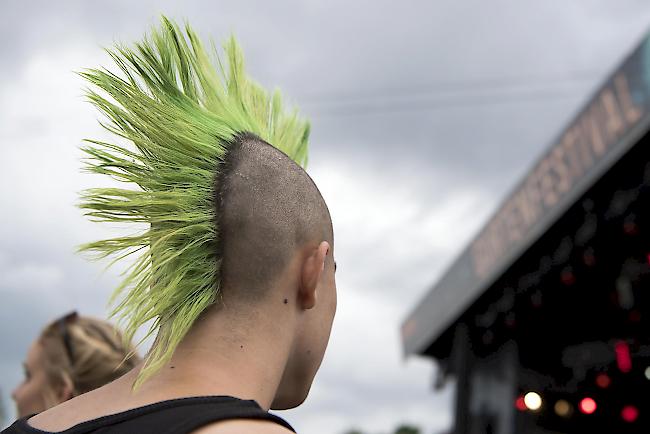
[124,298,294,410]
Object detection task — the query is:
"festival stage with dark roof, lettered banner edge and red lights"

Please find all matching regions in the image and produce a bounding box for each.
[401,30,650,434]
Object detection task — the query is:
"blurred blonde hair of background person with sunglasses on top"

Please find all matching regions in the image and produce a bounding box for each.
[39,313,141,401]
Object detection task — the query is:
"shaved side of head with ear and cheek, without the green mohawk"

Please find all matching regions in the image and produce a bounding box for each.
[215,134,336,409]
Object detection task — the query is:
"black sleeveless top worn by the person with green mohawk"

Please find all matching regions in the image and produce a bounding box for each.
[0,396,295,434]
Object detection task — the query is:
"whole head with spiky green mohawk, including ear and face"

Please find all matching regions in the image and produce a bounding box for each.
[81,17,336,407]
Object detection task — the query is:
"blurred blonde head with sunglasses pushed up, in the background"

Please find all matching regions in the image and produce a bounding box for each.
[12,313,139,417]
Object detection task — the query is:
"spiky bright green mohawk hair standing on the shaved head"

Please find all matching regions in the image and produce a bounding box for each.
[80,17,309,387]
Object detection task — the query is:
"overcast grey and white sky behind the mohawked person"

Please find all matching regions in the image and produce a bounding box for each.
[0,0,650,434]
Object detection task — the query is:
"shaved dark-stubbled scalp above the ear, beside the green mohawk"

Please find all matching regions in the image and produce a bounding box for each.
[215,133,333,296]
